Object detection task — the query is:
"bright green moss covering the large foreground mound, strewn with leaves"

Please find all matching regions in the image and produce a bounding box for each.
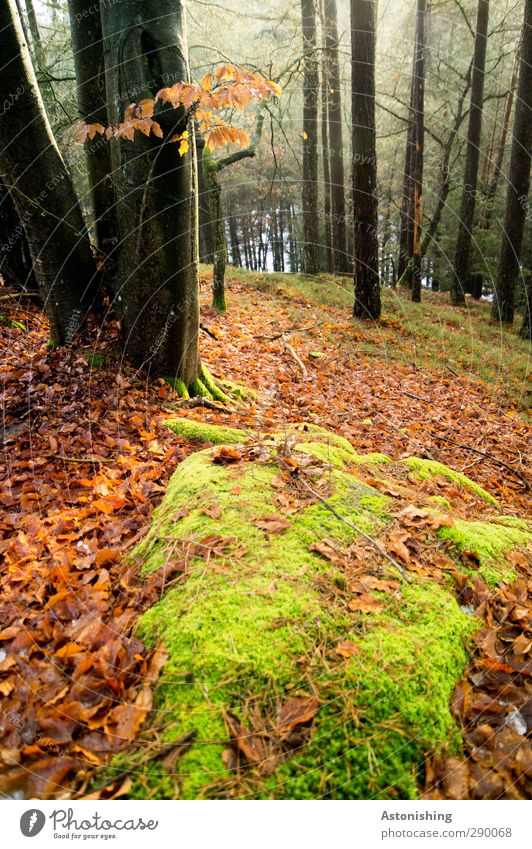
[121,419,531,799]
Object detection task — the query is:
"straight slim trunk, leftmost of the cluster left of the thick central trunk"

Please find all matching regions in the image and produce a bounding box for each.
[301,0,320,274]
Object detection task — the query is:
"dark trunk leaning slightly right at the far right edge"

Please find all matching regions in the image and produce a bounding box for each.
[492,0,532,324]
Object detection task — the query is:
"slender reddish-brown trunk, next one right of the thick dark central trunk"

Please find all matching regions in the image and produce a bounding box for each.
[412,0,427,302]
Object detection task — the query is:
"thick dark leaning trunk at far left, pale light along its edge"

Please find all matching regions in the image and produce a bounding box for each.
[0,0,98,345]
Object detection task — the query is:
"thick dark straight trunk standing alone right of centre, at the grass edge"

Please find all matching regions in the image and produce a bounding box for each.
[351,0,381,319]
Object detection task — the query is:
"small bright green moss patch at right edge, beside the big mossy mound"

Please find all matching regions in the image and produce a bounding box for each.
[439,516,532,586]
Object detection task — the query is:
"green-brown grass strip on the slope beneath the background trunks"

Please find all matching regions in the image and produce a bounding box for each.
[217,267,531,408]
